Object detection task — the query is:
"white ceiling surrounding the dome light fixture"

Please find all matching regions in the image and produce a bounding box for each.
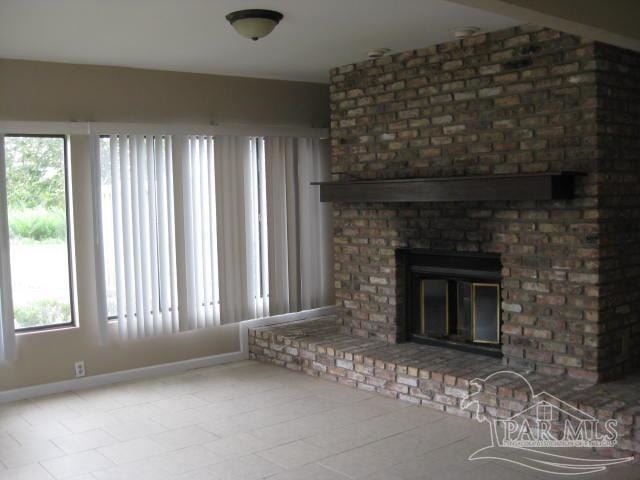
[0,0,521,82]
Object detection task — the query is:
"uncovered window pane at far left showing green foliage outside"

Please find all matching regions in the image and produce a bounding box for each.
[5,136,73,329]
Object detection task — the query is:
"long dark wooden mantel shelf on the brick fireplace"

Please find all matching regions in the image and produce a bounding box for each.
[312,172,578,203]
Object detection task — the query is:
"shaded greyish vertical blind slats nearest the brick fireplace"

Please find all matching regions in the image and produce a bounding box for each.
[264,137,333,314]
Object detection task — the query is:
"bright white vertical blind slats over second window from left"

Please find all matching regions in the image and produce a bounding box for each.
[93,135,178,339]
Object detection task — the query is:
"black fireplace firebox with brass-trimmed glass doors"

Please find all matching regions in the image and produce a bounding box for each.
[397,249,502,357]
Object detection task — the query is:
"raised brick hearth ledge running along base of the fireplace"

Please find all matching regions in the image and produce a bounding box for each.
[249,316,640,456]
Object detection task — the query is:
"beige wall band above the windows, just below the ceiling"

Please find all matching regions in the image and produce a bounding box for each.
[0,59,329,127]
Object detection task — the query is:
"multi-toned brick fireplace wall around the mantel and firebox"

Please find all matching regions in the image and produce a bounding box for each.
[330,26,640,381]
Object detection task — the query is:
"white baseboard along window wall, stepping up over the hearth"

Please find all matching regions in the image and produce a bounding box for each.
[0,306,335,404]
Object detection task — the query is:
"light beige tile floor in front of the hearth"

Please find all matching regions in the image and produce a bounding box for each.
[0,361,640,480]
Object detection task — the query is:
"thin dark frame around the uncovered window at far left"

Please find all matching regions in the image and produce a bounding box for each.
[4,133,78,335]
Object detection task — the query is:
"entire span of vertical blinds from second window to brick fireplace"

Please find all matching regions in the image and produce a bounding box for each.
[94,135,332,338]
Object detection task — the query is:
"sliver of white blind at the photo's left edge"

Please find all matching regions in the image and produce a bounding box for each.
[0,135,16,362]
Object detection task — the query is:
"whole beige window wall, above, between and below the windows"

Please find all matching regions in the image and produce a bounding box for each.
[0,60,328,391]
